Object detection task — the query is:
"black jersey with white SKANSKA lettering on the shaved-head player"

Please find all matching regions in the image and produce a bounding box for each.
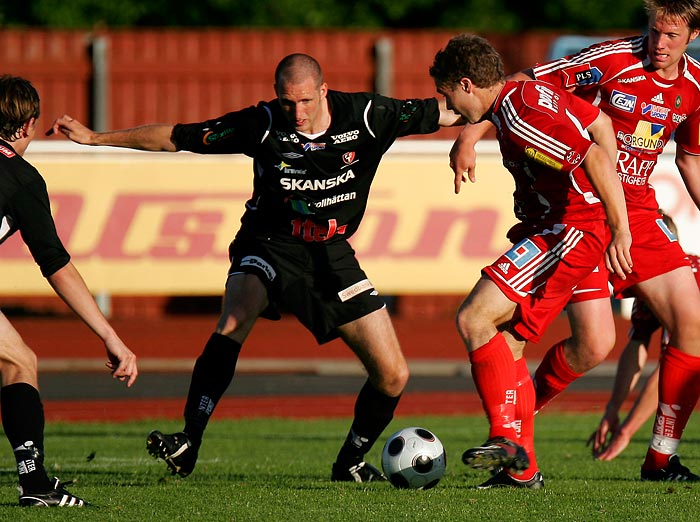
[172,91,440,242]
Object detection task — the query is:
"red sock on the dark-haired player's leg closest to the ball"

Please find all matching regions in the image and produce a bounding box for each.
[469,333,518,441]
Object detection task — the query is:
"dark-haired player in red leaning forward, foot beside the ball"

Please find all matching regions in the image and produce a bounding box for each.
[430,35,631,489]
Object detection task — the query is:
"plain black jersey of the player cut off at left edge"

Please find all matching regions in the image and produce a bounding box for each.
[0,140,70,277]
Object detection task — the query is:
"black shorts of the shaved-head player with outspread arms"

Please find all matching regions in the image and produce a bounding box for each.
[228,234,385,344]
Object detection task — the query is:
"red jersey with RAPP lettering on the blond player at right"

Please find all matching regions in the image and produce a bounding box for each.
[533,36,700,214]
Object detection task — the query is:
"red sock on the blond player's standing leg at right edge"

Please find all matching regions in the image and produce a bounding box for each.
[642,346,700,470]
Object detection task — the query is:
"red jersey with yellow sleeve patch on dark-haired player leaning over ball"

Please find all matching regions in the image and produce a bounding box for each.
[491,81,605,240]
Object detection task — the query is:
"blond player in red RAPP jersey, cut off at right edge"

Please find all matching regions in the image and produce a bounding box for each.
[450,0,700,481]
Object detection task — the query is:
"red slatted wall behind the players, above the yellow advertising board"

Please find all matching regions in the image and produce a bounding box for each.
[0,30,558,138]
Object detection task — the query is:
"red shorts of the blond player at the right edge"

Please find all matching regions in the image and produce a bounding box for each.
[610,207,690,298]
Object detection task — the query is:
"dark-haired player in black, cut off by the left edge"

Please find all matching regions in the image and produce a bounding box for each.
[0,75,138,507]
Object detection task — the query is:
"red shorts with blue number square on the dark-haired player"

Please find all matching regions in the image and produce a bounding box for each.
[483,221,606,342]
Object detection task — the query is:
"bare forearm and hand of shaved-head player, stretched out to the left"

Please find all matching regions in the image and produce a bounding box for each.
[46,114,177,152]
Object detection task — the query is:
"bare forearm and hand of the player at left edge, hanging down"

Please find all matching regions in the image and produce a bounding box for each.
[47,262,138,387]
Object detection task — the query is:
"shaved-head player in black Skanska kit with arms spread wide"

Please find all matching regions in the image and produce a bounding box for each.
[49,54,462,482]
